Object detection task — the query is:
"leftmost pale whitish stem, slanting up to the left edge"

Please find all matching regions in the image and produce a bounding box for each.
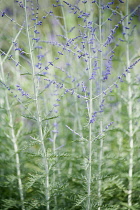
[0,56,25,210]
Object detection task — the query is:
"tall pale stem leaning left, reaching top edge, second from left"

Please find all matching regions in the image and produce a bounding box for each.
[25,0,50,210]
